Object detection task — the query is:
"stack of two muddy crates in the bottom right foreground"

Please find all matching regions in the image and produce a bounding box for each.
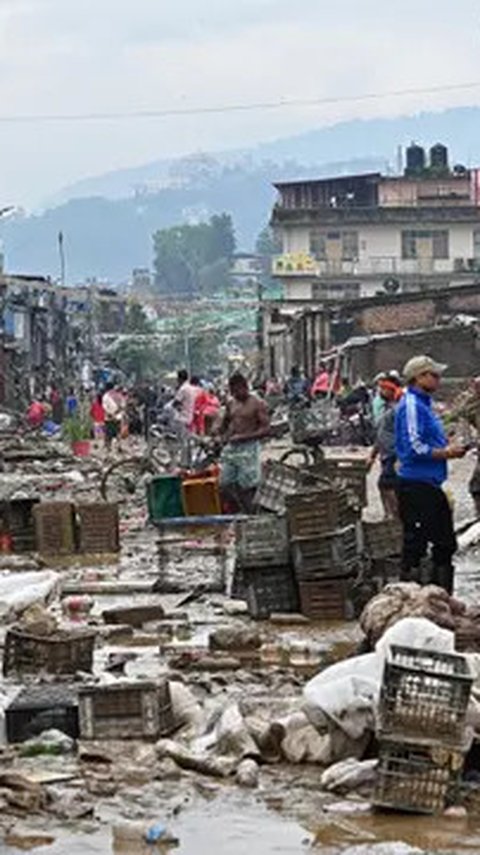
[374,646,473,814]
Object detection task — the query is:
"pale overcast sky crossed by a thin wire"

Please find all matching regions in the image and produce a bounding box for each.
[0,0,480,207]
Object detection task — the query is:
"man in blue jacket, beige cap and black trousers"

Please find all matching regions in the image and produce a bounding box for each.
[395,356,466,594]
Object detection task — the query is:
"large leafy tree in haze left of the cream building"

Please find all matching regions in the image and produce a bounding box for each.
[153,214,235,296]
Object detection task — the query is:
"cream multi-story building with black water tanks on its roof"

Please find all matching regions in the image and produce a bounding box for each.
[272,144,480,301]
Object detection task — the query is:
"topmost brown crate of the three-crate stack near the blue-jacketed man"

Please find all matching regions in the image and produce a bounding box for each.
[286,488,355,539]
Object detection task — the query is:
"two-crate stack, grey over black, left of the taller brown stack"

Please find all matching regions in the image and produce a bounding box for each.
[235,514,298,619]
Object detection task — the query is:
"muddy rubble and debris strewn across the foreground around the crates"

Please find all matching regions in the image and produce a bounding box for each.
[0,434,480,851]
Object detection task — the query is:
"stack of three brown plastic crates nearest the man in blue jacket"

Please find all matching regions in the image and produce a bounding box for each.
[285,487,360,620]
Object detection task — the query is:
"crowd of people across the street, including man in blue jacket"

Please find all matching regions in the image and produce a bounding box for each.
[26,356,480,592]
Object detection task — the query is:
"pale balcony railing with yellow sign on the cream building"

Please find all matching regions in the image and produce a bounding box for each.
[272,252,480,278]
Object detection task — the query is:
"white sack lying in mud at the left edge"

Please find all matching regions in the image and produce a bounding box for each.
[0,570,60,621]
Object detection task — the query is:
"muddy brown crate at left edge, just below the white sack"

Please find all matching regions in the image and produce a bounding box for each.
[3,627,96,677]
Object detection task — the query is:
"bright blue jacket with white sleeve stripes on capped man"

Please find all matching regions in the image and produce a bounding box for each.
[395,388,447,487]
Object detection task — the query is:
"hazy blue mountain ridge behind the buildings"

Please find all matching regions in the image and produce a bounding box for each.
[0,107,480,283]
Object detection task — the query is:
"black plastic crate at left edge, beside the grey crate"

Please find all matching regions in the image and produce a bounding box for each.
[5,684,80,742]
